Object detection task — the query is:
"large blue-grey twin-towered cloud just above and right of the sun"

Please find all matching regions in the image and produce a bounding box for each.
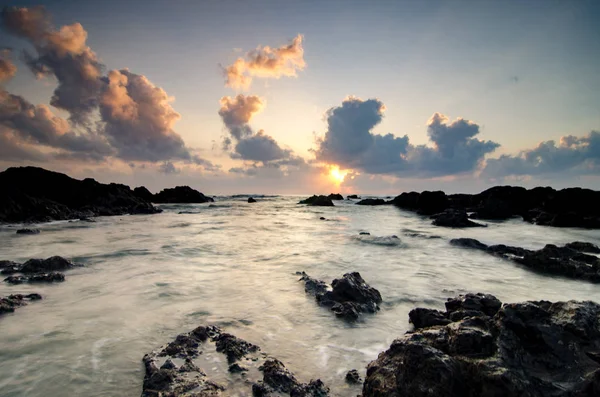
[314,97,499,177]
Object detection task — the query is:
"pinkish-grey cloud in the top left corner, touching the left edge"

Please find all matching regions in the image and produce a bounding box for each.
[0,6,103,124]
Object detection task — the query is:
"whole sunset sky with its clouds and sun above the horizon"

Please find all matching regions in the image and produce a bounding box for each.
[0,0,600,195]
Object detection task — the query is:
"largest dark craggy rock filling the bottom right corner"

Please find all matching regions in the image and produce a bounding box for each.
[362,294,600,397]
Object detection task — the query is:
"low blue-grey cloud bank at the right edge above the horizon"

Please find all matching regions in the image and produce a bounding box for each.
[481,131,600,178]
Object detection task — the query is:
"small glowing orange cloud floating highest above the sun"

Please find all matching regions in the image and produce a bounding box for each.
[223,34,306,89]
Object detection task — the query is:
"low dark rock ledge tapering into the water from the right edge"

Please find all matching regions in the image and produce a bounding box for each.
[450,238,600,283]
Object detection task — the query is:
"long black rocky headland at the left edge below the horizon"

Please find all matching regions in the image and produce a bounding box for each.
[0,167,160,222]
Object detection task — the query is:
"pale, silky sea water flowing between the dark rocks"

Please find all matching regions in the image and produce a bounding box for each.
[0,196,600,397]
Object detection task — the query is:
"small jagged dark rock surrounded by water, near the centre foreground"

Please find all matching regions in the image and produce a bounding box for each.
[297,272,382,321]
